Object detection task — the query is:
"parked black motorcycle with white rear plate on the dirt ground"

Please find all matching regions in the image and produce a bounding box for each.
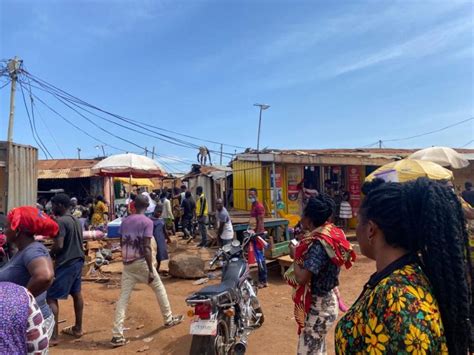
[186,231,265,355]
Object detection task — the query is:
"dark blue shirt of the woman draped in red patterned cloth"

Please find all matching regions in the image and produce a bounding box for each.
[303,241,341,296]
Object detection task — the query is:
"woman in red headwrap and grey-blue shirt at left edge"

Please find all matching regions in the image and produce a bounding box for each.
[0,206,59,342]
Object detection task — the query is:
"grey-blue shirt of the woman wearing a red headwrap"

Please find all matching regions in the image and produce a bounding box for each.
[0,242,51,319]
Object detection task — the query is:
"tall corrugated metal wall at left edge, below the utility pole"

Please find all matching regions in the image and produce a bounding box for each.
[0,141,38,214]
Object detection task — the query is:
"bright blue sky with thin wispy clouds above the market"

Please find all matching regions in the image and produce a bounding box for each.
[0,0,474,171]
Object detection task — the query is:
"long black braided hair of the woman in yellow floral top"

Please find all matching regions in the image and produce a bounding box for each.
[360,178,472,355]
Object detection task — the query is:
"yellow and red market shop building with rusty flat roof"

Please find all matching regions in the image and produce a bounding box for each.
[232,148,474,226]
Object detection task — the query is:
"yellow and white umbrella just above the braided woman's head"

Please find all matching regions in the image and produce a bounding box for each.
[365,159,453,182]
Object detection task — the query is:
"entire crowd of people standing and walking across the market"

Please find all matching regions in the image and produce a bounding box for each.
[0,178,474,354]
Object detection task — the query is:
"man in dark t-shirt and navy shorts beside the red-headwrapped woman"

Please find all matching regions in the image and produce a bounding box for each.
[47,194,84,342]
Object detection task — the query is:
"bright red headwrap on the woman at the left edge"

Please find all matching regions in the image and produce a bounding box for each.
[7,206,59,237]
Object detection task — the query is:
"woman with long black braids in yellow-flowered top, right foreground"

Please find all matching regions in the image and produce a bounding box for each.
[336,178,473,355]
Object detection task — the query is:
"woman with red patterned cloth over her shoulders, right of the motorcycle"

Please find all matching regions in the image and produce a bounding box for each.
[285,194,355,355]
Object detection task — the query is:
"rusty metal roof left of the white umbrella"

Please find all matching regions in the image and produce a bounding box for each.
[38,159,100,179]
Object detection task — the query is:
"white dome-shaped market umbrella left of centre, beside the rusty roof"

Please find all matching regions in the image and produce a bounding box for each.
[92,153,166,178]
